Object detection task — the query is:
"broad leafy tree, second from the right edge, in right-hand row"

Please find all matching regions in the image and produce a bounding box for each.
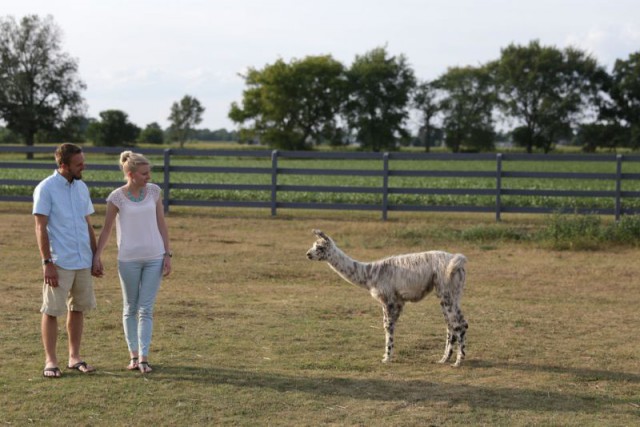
[489,40,607,153]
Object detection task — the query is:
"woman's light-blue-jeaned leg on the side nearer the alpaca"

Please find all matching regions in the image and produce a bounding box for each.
[138,258,164,363]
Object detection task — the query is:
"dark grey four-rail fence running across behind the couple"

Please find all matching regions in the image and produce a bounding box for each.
[0,146,640,221]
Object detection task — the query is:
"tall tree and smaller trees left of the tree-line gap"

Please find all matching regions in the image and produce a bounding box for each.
[0,15,237,156]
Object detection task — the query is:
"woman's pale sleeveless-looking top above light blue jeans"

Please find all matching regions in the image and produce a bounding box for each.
[107,183,165,261]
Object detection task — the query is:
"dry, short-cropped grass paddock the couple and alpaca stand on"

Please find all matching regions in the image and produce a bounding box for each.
[0,203,640,426]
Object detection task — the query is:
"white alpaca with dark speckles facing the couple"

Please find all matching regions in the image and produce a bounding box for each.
[307,230,469,366]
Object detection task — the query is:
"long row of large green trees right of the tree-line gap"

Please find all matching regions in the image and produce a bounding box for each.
[229,41,640,152]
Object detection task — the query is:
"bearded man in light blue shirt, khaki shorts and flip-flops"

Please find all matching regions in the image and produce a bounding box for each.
[33,144,96,378]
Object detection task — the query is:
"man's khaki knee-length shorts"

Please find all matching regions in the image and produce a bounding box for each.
[40,265,96,317]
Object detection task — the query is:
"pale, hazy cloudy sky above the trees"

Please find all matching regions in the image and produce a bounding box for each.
[0,0,640,130]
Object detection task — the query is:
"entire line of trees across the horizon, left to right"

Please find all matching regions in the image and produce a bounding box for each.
[0,15,640,152]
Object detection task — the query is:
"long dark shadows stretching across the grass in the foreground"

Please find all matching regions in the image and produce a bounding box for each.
[155,366,638,414]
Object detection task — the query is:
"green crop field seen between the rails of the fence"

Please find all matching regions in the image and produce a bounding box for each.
[0,150,640,210]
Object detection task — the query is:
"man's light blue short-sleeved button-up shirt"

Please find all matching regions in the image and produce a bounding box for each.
[33,170,95,270]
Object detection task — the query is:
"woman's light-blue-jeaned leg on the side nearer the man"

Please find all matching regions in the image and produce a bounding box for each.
[118,261,143,358]
